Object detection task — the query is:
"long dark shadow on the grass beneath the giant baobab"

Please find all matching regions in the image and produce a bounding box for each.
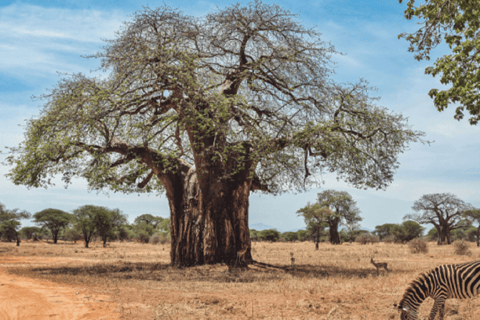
[21,261,405,283]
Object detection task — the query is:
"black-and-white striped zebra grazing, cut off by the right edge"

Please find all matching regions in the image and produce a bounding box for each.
[394,261,480,320]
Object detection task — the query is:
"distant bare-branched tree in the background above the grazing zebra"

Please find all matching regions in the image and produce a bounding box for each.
[404,193,473,244]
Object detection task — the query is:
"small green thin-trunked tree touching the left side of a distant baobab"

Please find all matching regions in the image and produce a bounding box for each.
[297,203,332,250]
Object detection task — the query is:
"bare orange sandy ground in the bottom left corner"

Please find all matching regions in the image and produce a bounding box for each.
[0,269,119,320]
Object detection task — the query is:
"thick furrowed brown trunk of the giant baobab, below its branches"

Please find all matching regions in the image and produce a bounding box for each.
[166,169,252,266]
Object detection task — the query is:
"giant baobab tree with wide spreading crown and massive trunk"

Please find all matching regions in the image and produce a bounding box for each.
[3,1,423,265]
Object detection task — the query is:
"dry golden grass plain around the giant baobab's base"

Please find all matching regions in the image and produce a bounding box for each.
[0,242,480,320]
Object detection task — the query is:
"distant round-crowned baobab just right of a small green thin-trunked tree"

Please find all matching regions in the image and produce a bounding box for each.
[316,190,362,244]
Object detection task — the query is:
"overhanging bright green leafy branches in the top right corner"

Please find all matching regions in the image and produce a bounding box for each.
[398,0,480,125]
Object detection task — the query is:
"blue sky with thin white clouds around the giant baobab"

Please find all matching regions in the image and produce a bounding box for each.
[0,0,480,231]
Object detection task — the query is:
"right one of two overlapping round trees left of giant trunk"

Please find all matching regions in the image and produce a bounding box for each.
[94,207,127,247]
